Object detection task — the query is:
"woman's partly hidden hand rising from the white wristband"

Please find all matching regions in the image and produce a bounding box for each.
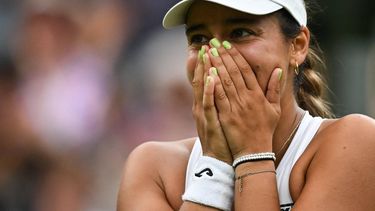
[191,46,233,165]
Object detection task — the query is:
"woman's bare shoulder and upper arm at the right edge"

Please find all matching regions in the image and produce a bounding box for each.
[293,115,375,211]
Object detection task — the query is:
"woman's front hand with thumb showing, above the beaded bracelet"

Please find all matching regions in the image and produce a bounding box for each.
[209,40,282,159]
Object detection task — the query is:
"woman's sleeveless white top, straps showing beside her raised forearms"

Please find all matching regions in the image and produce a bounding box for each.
[185,111,323,211]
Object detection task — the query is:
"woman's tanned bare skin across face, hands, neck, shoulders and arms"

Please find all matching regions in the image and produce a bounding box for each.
[118,1,375,211]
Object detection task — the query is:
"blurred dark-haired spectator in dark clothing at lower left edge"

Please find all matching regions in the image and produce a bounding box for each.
[0,56,88,211]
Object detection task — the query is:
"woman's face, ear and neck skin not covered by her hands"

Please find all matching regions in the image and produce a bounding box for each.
[186,2,309,166]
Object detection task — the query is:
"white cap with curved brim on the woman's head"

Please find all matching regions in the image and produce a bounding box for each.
[163,0,307,29]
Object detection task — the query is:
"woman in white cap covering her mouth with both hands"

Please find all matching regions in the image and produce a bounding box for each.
[118,0,375,211]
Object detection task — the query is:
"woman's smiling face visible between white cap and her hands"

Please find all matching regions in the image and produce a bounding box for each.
[186,1,292,91]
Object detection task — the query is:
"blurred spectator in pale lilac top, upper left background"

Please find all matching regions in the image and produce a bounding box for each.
[12,1,123,151]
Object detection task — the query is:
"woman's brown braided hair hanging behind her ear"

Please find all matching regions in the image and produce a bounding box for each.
[276,0,334,118]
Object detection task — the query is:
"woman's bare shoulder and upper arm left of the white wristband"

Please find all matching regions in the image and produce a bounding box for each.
[118,138,196,210]
